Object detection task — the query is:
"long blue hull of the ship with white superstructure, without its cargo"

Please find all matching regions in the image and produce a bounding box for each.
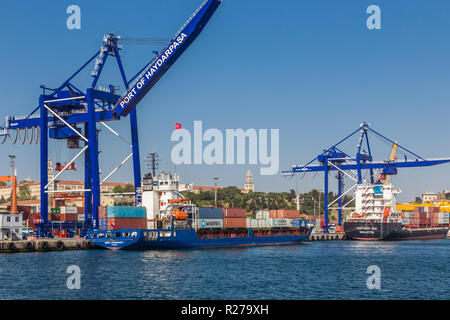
[88,226,313,250]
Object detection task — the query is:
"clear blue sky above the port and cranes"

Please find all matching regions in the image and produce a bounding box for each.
[0,0,450,200]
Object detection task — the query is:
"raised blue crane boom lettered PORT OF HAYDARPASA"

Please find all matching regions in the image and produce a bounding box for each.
[113,0,221,117]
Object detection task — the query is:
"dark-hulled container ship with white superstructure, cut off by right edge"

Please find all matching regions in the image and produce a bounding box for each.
[344,182,449,240]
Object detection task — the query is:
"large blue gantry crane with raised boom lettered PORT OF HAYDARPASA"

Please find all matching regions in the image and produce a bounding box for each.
[0,0,221,236]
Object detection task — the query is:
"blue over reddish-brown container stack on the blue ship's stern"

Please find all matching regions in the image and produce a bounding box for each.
[106,207,147,230]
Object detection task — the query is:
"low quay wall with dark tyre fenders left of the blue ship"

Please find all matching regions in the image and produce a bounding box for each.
[0,238,94,253]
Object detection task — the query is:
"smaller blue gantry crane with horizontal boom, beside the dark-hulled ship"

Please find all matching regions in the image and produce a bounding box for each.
[282,122,450,232]
